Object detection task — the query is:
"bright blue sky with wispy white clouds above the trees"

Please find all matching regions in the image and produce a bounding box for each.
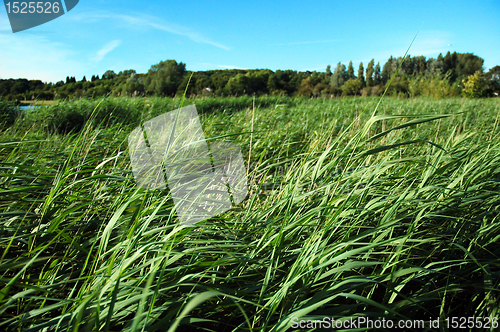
[0,0,500,82]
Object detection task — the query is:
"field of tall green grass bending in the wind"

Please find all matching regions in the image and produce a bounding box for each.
[0,97,500,331]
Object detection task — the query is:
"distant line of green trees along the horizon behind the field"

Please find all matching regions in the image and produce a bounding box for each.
[0,52,500,101]
